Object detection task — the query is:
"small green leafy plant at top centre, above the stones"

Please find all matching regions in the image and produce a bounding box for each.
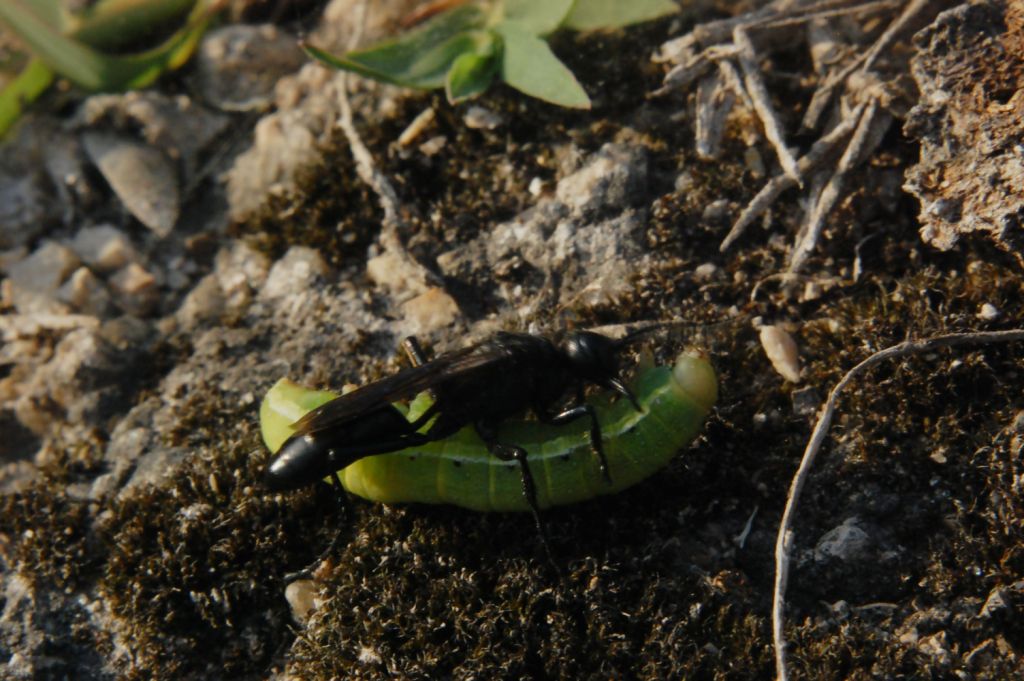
[305,0,678,109]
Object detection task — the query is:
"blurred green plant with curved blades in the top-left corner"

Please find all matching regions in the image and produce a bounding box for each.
[0,0,223,135]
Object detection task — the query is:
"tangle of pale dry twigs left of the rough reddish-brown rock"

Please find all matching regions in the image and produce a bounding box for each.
[656,0,942,271]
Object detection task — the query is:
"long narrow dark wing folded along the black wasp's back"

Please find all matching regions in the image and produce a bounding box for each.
[292,343,506,435]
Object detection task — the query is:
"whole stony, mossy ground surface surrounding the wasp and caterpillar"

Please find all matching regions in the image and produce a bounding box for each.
[0,0,1024,679]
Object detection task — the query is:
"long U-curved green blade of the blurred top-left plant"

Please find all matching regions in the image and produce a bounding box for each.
[0,0,210,90]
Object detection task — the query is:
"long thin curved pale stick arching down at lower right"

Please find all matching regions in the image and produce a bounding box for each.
[772,329,1024,681]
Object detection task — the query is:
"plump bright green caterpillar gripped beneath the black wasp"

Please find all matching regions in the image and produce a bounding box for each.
[260,351,718,511]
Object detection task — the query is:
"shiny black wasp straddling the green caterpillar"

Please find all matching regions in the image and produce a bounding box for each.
[264,330,646,517]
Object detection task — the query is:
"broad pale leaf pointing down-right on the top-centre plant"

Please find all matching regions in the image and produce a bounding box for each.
[495,22,590,109]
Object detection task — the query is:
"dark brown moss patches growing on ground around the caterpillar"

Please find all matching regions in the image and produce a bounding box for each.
[0,9,1024,679]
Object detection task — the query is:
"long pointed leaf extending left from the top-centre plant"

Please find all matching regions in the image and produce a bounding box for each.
[305,5,485,89]
